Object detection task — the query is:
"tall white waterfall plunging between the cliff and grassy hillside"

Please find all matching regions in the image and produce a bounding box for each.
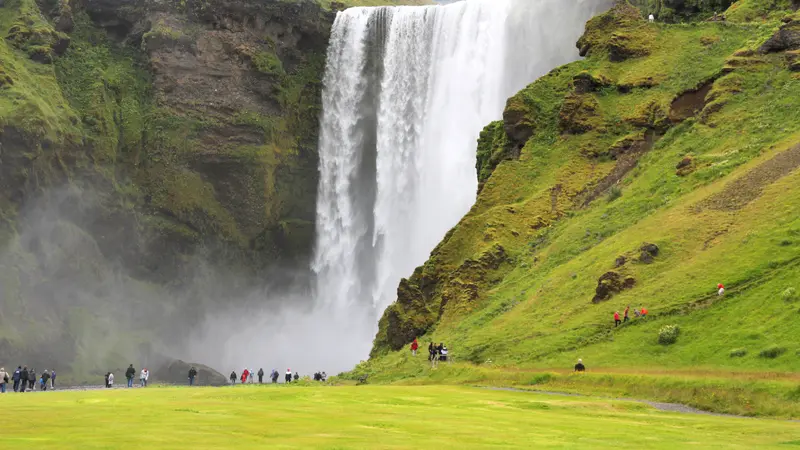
[314,0,610,343]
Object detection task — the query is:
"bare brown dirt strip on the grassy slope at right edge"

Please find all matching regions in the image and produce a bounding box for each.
[696,145,800,212]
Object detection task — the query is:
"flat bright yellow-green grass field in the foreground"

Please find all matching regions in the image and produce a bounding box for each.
[0,386,800,449]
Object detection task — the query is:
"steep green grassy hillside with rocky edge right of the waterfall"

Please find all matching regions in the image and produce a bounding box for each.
[366,1,800,416]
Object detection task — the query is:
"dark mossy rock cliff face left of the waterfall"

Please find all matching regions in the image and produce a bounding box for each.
[0,0,334,376]
